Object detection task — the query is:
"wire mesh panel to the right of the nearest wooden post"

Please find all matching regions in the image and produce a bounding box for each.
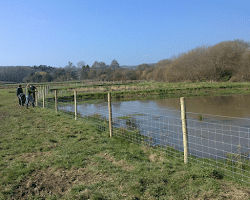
[184,113,250,183]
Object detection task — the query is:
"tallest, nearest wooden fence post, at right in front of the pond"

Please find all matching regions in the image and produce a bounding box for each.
[180,97,188,163]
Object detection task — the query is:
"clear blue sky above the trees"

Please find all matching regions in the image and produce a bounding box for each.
[0,0,250,67]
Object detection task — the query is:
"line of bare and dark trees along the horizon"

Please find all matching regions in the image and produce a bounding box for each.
[0,40,250,83]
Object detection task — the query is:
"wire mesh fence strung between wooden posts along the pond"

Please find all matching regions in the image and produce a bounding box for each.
[34,86,250,183]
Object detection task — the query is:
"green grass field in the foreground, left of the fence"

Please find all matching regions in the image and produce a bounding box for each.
[0,82,250,199]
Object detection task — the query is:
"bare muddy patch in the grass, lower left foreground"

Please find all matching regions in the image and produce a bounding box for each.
[12,168,108,199]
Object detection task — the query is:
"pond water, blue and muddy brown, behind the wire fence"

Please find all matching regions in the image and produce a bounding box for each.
[59,95,250,159]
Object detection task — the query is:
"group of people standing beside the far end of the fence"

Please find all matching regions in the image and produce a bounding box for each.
[16,84,36,108]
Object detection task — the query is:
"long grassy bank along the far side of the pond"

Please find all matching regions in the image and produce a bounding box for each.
[51,82,250,101]
